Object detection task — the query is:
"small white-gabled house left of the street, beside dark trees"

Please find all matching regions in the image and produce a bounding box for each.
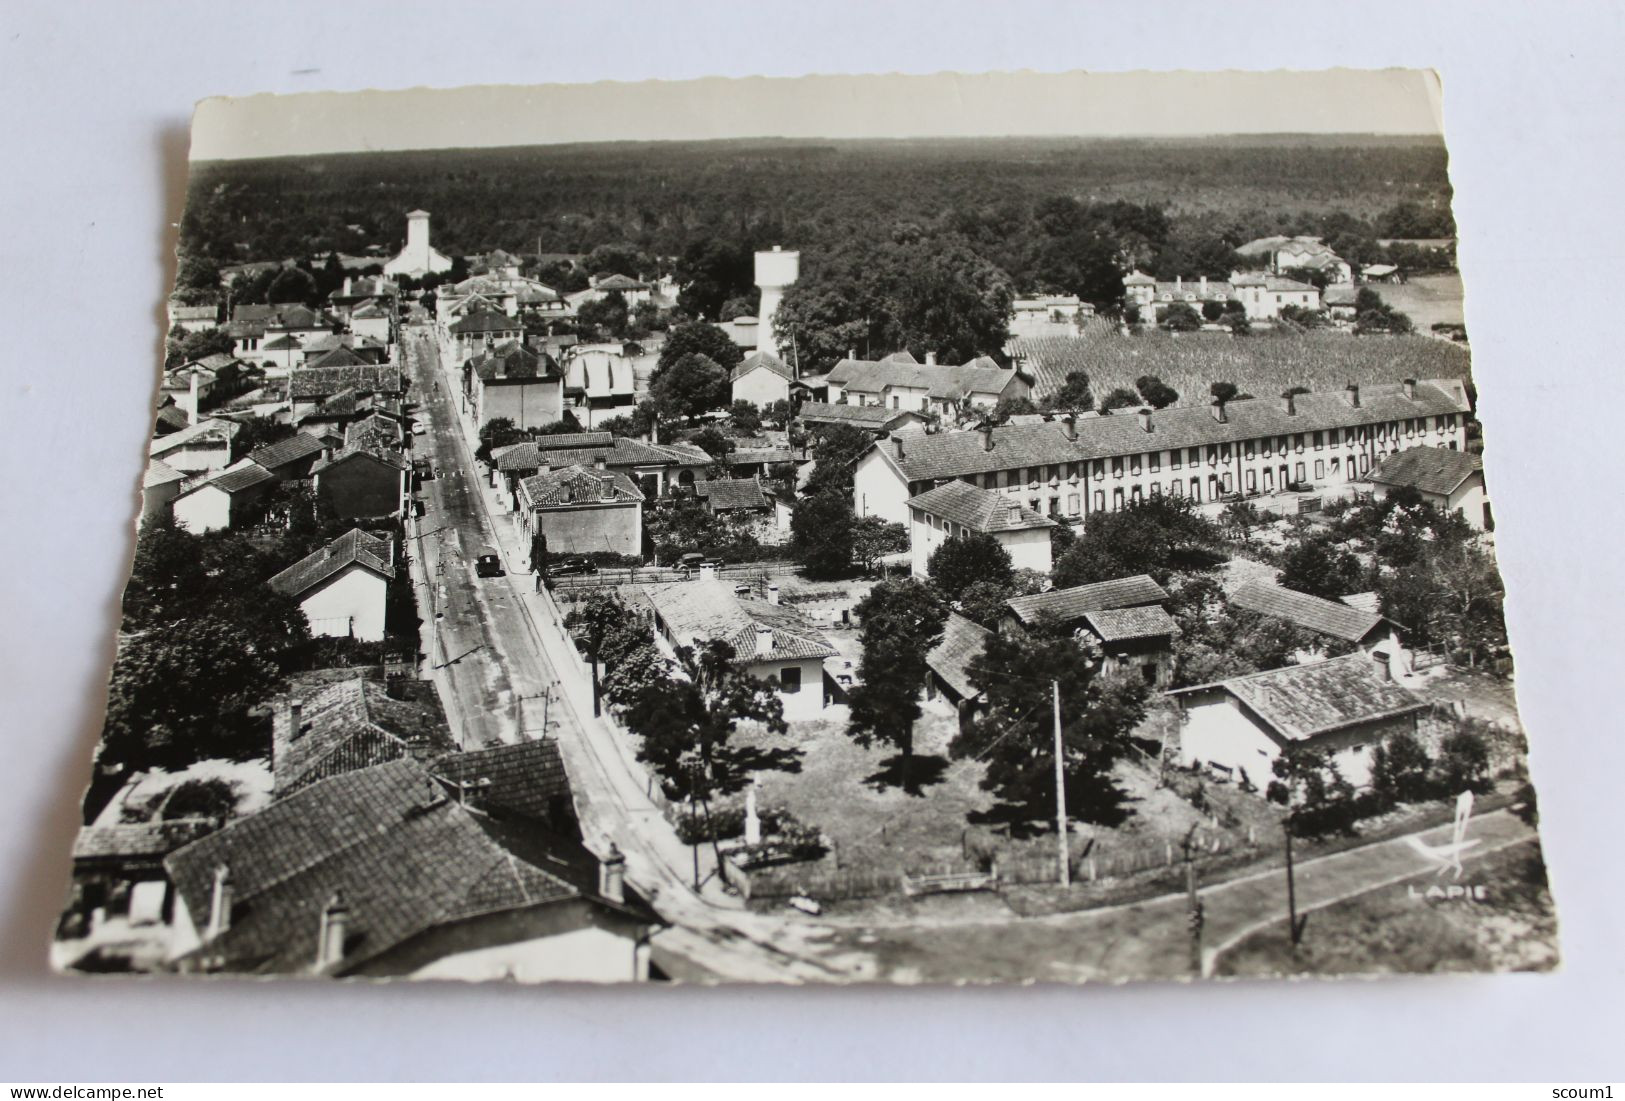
[268,528,395,641]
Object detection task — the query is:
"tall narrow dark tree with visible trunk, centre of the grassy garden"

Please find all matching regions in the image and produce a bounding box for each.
[847,578,947,794]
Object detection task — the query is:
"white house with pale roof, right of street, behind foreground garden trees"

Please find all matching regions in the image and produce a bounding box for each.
[640,578,837,719]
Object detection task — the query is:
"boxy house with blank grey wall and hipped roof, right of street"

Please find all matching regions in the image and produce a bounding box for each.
[518,466,644,559]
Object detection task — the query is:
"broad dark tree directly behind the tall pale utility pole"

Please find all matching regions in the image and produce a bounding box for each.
[949,617,1149,825]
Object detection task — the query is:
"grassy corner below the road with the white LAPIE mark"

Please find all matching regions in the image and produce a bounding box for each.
[1217,841,1557,978]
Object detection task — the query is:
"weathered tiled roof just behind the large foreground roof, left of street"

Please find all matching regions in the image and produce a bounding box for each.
[271,672,453,799]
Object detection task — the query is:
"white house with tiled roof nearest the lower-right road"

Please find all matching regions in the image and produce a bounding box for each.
[1168,653,1430,791]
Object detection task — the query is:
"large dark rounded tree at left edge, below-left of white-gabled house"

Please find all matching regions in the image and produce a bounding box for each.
[101,615,276,770]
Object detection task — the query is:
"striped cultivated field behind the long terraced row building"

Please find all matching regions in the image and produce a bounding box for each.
[1016,332,1471,414]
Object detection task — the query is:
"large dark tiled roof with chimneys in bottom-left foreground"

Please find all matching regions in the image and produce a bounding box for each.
[164,760,583,973]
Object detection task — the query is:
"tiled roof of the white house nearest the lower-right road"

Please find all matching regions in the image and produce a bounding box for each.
[1178,653,1427,742]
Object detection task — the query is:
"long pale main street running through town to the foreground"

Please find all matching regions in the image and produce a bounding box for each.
[401,326,866,982]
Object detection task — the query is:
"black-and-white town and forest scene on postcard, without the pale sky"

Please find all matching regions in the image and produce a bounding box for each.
[50,75,1558,984]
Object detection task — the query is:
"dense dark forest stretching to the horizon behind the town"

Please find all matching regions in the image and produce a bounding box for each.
[182,135,1451,281]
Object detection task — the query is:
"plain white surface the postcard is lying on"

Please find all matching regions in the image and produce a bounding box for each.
[0,0,1625,1083]
